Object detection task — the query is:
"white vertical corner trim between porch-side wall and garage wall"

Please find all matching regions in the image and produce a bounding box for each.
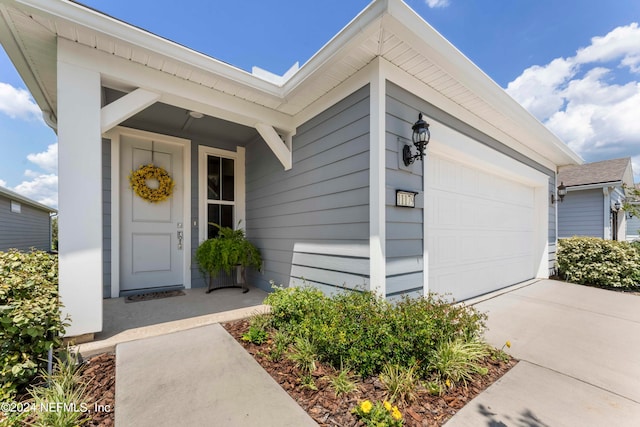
[369,62,387,297]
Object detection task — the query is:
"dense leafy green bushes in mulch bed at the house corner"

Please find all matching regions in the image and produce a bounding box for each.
[265,286,485,377]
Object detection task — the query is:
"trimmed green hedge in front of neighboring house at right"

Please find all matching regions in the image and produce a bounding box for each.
[558,237,640,288]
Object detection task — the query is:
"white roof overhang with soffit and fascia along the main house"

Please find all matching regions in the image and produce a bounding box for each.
[0,0,582,169]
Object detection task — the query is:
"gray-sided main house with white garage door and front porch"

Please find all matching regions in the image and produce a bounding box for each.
[0,0,582,335]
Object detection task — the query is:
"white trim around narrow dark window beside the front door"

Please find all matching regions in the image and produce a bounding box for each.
[198,145,246,242]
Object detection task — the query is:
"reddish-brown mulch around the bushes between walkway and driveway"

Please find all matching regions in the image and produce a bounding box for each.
[223,320,517,427]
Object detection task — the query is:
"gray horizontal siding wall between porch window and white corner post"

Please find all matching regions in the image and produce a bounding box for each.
[246,86,369,293]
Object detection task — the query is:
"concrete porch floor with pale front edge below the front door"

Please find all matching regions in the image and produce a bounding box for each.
[74,286,268,357]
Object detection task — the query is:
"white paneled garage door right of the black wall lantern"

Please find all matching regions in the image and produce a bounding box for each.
[426,153,536,301]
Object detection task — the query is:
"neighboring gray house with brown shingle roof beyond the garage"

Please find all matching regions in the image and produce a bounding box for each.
[558,157,633,240]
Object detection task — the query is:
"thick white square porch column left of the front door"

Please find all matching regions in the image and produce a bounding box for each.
[58,42,103,336]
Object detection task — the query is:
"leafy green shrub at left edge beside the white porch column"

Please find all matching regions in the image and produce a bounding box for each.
[0,250,67,401]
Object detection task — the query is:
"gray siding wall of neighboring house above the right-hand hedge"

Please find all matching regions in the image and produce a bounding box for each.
[558,189,604,238]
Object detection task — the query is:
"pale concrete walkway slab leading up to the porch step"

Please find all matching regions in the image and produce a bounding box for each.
[115,324,317,427]
